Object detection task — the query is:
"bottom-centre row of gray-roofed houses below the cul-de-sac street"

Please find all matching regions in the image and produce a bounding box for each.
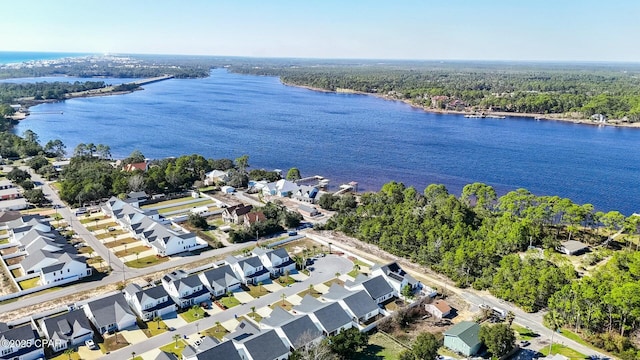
[176,263,430,360]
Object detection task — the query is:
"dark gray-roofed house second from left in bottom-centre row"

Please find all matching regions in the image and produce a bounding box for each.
[237,330,290,360]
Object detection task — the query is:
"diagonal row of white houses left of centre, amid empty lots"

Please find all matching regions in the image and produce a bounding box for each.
[102,197,207,256]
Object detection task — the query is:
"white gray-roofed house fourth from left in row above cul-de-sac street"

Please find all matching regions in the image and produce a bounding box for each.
[123,284,177,321]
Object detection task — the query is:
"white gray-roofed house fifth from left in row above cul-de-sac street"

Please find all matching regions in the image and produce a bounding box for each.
[162,270,211,309]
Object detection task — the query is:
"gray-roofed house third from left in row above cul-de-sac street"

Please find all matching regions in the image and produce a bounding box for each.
[83,293,136,334]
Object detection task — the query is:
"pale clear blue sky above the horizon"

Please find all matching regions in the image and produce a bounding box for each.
[0,0,640,62]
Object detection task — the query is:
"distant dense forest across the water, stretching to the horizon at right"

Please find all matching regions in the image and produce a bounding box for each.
[232,62,640,121]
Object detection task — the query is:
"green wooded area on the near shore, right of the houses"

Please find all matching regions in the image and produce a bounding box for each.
[320,182,640,359]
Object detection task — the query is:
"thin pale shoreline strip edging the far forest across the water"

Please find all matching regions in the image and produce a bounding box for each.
[281,81,640,129]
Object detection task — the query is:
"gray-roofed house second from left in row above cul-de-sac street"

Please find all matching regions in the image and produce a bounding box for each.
[39,310,93,352]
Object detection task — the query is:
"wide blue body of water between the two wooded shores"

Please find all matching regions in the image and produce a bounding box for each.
[16,70,640,215]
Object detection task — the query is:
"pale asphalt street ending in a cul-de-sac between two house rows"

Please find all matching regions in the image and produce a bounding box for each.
[101,255,353,360]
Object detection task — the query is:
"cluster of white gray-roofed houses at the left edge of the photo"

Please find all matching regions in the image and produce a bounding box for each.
[0,214,92,285]
